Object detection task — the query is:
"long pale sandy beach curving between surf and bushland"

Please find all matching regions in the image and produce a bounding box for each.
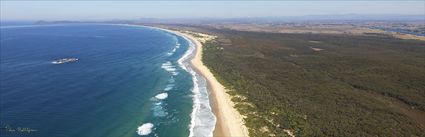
[161,30,248,137]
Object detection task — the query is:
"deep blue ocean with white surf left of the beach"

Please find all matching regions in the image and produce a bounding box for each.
[0,24,215,137]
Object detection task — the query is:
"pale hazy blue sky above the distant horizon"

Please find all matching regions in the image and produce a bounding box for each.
[0,0,425,21]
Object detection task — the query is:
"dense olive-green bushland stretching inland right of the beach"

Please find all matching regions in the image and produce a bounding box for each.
[202,29,425,137]
